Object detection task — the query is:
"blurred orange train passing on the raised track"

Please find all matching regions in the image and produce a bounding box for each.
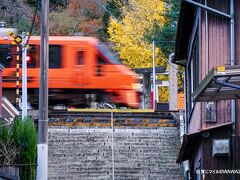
[0,36,139,108]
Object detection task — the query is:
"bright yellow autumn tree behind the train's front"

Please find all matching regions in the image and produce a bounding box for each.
[108,0,166,68]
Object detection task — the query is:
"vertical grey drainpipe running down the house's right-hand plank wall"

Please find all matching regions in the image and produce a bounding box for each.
[230,0,236,180]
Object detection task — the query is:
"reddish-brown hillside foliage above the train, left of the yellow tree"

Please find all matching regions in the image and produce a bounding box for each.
[0,0,107,37]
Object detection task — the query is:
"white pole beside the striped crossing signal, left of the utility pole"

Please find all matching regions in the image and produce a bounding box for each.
[22,32,27,120]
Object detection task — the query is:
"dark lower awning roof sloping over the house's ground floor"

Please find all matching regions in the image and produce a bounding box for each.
[176,122,232,163]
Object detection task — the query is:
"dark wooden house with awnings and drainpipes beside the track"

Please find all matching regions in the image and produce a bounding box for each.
[172,0,240,180]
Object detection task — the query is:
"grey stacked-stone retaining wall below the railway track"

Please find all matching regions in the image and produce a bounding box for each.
[49,127,182,180]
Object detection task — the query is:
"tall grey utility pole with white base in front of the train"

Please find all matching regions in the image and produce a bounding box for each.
[37,0,49,180]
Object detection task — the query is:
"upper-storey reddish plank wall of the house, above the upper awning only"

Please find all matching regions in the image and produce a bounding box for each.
[200,0,230,76]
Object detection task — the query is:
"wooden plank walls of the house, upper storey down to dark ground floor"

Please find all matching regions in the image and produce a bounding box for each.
[184,0,240,175]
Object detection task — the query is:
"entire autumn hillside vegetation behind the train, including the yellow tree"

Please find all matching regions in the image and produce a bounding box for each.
[0,0,180,102]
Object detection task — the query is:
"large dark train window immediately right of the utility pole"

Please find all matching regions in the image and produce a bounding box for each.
[49,45,62,69]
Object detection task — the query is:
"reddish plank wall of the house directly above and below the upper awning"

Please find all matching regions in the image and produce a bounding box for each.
[196,0,231,129]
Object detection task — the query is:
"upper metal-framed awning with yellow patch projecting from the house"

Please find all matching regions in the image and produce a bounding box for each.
[192,66,240,101]
